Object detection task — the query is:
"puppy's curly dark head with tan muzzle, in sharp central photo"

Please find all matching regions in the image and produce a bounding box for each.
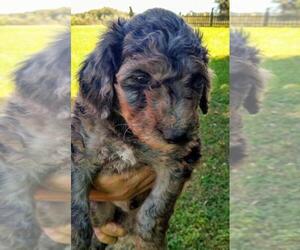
[80,9,209,150]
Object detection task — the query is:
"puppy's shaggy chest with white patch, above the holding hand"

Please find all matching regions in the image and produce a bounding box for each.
[78,116,169,174]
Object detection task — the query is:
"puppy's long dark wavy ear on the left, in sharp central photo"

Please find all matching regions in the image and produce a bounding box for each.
[79,19,126,119]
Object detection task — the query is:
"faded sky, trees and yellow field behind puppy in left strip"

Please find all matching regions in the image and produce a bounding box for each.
[0,0,71,99]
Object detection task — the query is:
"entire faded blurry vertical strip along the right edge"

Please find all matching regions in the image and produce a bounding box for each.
[230,0,300,250]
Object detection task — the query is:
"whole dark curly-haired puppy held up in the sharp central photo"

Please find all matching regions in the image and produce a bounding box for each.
[72,9,209,250]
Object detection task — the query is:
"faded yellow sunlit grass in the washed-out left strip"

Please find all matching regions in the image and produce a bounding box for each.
[0,25,62,98]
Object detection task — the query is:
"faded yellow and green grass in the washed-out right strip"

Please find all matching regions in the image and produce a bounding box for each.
[230,28,300,250]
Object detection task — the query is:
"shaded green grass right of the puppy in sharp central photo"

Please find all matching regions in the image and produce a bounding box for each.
[168,57,229,250]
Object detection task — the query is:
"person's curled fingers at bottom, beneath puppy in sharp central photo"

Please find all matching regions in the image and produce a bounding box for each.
[94,222,126,245]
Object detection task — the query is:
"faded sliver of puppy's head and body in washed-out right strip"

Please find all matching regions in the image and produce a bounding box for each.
[230,31,269,166]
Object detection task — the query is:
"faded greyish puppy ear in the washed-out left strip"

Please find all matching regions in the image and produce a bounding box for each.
[14,31,71,114]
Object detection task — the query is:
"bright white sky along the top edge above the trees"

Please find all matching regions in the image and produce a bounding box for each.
[0,0,274,14]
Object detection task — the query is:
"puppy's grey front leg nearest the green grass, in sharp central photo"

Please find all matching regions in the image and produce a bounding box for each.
[136,161,191,250]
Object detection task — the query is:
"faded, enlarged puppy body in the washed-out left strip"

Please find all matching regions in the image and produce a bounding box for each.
[0,33,71,250]
